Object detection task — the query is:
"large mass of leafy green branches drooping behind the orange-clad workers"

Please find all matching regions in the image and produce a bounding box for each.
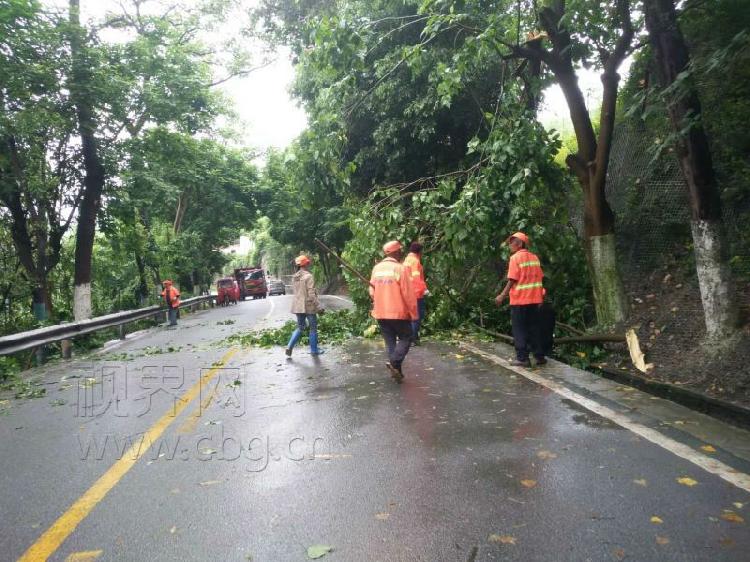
[260,1,590,325]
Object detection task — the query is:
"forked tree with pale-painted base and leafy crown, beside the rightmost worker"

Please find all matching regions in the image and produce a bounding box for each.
[421,0,635,325]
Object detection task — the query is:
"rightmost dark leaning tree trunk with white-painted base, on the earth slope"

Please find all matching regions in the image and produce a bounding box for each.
[644,0,738,340]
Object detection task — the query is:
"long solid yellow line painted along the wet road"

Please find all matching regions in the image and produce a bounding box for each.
[18,348,239,562]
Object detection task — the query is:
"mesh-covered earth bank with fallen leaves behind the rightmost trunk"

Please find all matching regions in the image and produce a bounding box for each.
[572,124,750,404]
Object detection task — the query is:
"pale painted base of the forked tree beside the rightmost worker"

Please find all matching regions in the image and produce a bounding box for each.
[589,234,628,327]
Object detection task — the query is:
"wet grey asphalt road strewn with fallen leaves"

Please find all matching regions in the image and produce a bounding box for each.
[0,297,750,561]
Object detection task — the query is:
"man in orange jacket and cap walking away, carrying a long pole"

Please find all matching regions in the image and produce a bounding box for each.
[370,240,419,383]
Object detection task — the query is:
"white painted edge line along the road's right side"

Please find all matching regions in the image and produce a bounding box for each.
[461,336,750,492]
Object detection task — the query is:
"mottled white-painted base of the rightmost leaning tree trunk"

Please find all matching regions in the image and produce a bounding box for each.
[690,220,738,341]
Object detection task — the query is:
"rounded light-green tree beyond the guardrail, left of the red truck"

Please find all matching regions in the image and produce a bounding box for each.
[114,127,259,290]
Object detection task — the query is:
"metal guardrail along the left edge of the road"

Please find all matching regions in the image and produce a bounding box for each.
[0,295,216,355]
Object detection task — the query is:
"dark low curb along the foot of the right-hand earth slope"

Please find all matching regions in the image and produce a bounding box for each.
[595,367,750,429]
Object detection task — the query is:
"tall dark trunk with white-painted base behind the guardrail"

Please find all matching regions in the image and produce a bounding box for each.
[69,0,105,321]
